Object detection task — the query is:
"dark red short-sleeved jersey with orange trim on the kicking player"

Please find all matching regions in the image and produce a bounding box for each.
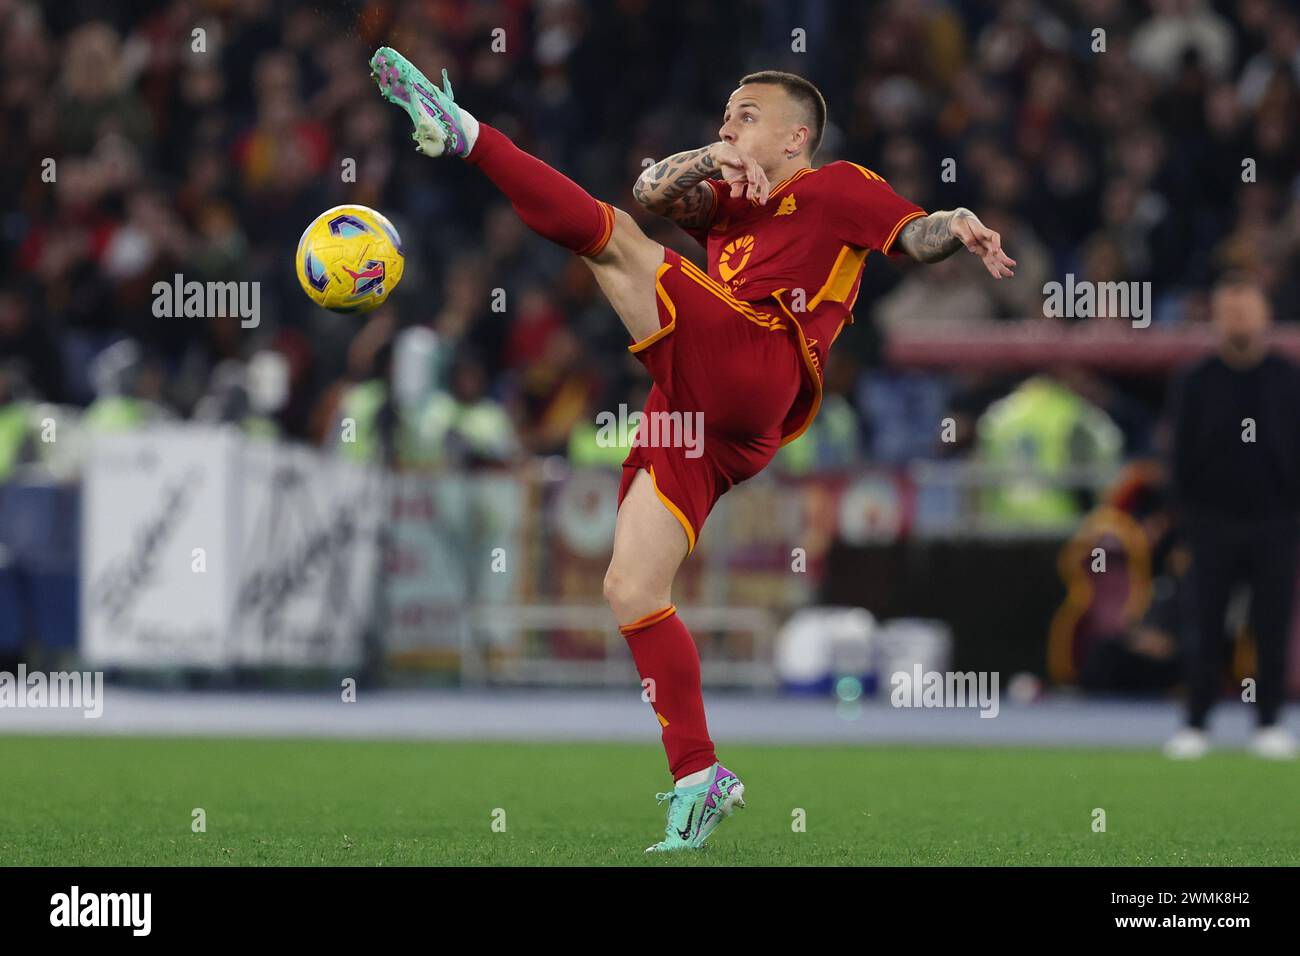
[686,161,926,442]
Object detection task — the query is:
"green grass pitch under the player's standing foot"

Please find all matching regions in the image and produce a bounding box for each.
[0,737,1300,866]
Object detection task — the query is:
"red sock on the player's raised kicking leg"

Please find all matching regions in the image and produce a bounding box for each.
[465,122,614,256]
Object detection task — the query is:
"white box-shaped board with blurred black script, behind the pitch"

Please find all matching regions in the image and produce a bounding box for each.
[82,425,385,667]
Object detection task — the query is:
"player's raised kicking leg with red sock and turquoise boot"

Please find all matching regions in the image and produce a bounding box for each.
[371,47,663,341]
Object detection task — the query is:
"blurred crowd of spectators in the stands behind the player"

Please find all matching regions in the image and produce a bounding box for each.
[0,0,1300,480]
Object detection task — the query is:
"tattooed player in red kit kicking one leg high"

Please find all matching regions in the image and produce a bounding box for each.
[371,47,1015,852]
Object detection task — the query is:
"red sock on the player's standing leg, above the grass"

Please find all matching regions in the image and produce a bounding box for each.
[619,605,718,780]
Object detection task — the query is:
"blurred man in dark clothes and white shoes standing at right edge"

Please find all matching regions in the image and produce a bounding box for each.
[1165,276,1300,758]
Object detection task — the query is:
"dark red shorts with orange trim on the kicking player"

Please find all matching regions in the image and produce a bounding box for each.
[619,248,802,550]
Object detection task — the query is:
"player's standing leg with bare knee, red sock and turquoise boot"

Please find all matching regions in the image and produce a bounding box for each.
[605,470,745,852]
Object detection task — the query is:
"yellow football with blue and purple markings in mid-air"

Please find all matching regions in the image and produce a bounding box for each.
[295,206,406,312]
